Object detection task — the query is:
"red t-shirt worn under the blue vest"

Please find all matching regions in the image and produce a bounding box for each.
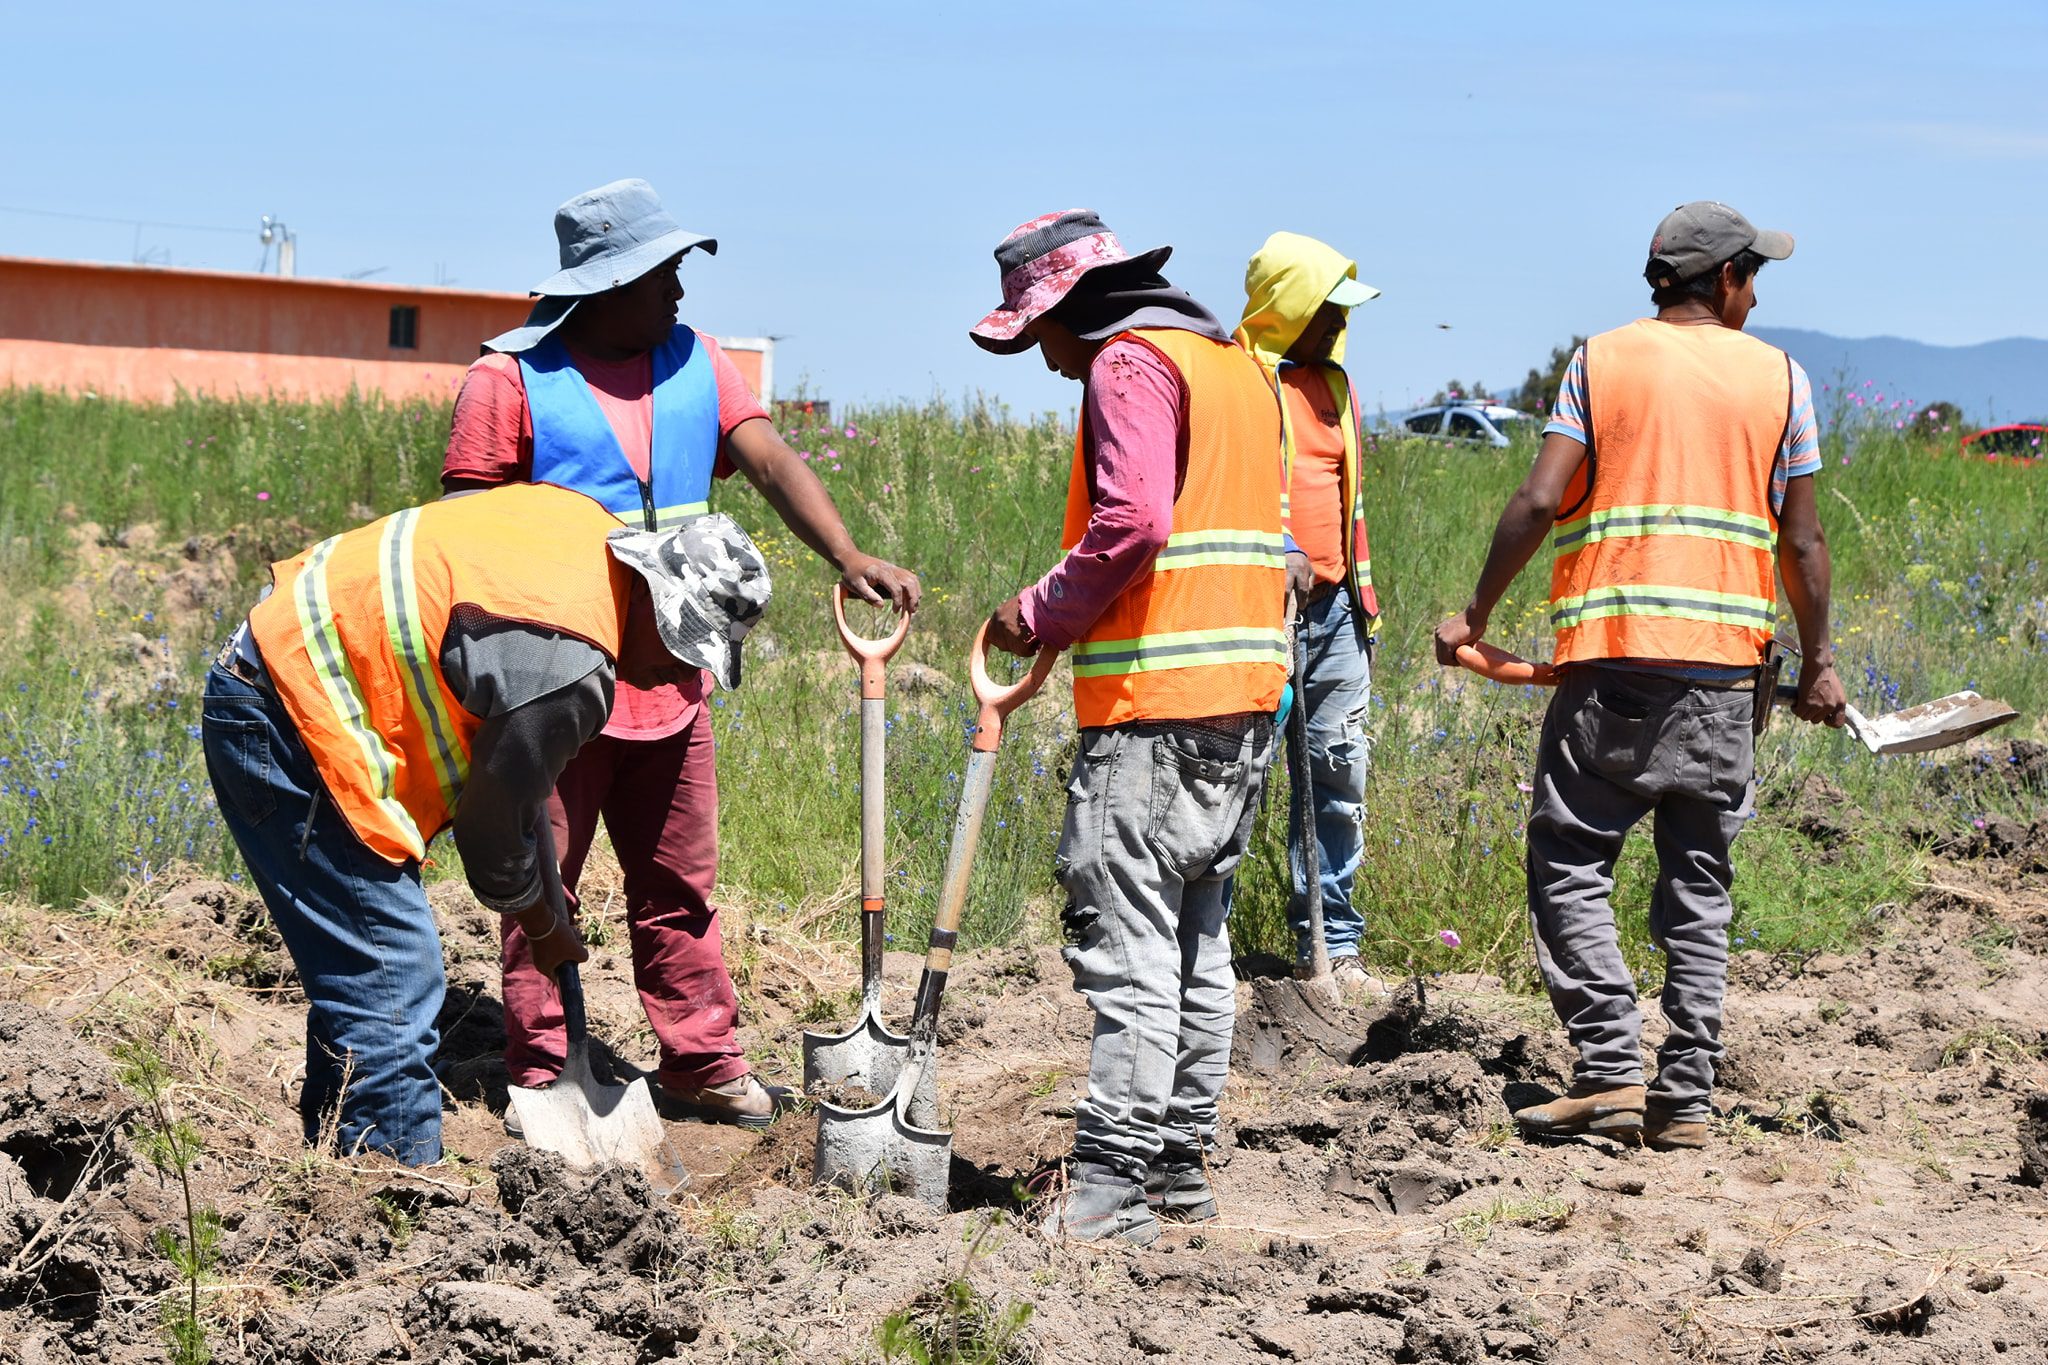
[440,332,768,739]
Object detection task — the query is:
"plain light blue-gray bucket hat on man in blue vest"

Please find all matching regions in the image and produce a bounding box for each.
[483,180,719,354]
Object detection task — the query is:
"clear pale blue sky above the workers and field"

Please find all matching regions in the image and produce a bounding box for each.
[0,0,2048,409]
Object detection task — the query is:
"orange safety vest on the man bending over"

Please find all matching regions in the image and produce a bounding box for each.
[250,483,633,864]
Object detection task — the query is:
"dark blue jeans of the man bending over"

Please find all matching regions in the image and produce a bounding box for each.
[201,667,442,1166]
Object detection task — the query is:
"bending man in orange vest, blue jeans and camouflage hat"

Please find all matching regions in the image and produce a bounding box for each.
[201,485,768,1164]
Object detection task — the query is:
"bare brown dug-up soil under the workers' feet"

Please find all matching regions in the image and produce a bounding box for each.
[0,821,2048,1365]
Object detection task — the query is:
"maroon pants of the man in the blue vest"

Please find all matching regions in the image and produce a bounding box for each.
[504,714,748,1089]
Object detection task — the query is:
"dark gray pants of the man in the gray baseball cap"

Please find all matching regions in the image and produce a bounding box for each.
[1528,665,1755,1119]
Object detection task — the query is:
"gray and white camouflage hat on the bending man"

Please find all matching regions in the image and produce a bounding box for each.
[606,512,770,688]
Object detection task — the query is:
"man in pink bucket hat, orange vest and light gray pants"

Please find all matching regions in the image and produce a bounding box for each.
[971,209,1307,1244]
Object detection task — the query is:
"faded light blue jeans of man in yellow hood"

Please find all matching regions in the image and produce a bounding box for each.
[1288,587,1372,966]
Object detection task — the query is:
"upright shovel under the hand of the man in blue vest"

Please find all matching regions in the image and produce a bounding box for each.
[803,583,909,1095]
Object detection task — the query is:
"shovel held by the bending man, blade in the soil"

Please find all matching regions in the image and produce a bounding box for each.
[510,810,676,1177]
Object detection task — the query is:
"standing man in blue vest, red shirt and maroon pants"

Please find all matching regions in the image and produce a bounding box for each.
[452,180,920,1128]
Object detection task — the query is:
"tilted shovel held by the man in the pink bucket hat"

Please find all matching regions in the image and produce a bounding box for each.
[815,622,1059,1209]
